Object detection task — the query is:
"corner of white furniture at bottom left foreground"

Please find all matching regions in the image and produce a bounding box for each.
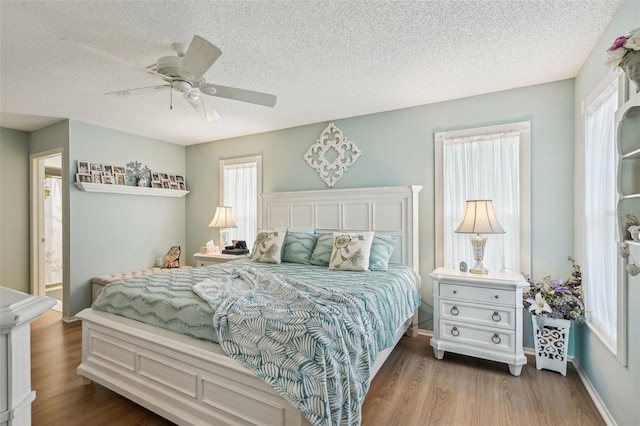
[0,287,56,426]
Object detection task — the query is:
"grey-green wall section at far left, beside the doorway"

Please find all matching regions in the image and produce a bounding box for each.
[0,128,30,293]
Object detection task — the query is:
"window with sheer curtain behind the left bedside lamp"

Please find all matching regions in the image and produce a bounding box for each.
[220,156,262,247]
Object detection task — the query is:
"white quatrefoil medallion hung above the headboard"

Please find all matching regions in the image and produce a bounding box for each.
[304,123,362,188]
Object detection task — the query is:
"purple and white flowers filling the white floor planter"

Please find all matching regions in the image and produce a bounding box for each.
[523,257,585,324]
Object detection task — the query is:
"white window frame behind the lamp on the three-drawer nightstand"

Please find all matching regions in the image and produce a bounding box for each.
[434,121,531,274]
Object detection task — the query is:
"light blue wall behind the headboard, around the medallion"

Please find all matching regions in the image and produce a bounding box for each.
[187,80,573,334]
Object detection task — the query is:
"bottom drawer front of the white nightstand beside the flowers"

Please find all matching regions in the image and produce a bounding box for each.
[440,321,515,353]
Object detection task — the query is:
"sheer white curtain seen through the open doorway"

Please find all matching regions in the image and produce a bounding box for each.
[44,176,62,285]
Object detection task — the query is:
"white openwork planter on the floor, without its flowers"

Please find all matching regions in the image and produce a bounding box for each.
[531,315,571,376]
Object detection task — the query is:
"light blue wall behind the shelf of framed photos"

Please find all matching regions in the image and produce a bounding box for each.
[65,121,189,315]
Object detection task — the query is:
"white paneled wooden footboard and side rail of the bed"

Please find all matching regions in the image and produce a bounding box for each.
[77,308,417,426]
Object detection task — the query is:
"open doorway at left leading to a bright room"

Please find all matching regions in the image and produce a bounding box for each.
[31,150,64,312]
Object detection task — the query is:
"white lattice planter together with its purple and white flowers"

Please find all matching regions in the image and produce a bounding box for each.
[523,257,585,376]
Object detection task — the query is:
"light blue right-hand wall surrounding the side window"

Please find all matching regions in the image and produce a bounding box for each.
[574,1,640,425]
